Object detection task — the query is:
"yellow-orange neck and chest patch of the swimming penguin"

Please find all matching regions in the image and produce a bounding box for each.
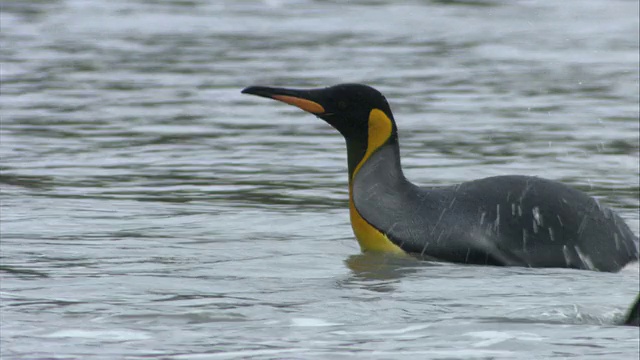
[349,109,404,254]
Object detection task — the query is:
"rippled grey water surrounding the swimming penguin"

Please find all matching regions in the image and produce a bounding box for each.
[0,0,640,359]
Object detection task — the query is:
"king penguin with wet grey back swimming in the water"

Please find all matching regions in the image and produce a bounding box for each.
[242,84,638,272]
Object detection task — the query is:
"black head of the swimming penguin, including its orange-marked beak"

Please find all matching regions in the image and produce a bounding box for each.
[242,84,396,141]
